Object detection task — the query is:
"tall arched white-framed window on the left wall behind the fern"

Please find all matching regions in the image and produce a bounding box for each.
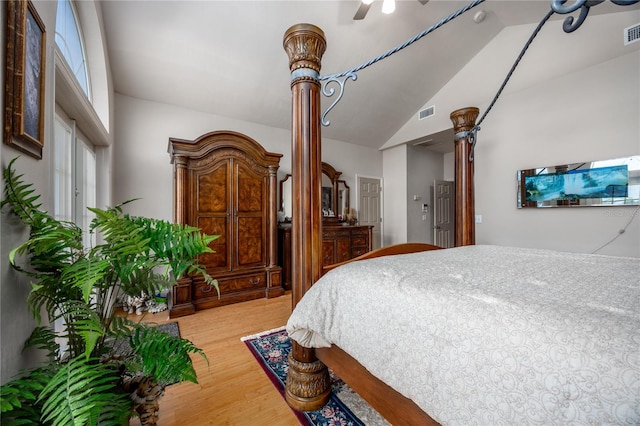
[48,0,111,350]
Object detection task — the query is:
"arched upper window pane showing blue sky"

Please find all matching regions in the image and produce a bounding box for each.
[56,0,91,99]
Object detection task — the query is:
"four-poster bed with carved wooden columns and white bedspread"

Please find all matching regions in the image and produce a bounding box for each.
[283,7,640,425]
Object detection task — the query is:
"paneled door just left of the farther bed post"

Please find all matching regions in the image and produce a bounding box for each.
[433,180,455,248]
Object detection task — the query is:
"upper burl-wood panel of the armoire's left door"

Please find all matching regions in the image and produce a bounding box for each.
[196,161,230,214]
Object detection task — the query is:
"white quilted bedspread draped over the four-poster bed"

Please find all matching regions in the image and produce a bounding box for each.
[287,246,640,426]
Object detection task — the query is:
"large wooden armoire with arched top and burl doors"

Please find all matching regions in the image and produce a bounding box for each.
[169,131,284,318]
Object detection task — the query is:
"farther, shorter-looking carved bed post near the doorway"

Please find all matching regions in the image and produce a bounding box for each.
[450,107,480,247]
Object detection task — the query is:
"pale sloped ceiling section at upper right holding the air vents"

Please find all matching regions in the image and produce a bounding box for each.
[382,11,640,149]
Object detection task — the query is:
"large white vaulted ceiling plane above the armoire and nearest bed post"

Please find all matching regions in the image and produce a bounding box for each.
[101,0,636,148]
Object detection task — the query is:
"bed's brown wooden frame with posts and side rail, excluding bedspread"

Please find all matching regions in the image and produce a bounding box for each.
[283,24,478,424]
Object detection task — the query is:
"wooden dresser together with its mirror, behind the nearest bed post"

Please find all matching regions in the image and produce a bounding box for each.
[278,162,373,290]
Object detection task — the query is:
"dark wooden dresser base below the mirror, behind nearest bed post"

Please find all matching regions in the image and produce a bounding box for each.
[278,223,373,290]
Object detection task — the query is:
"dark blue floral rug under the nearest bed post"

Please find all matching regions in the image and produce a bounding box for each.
[241,327,389,426]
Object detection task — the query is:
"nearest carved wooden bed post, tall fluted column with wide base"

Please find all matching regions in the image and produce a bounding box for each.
[283,24,331,411]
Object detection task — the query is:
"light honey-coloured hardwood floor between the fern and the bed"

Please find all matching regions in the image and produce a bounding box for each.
[130,292,299,426]
